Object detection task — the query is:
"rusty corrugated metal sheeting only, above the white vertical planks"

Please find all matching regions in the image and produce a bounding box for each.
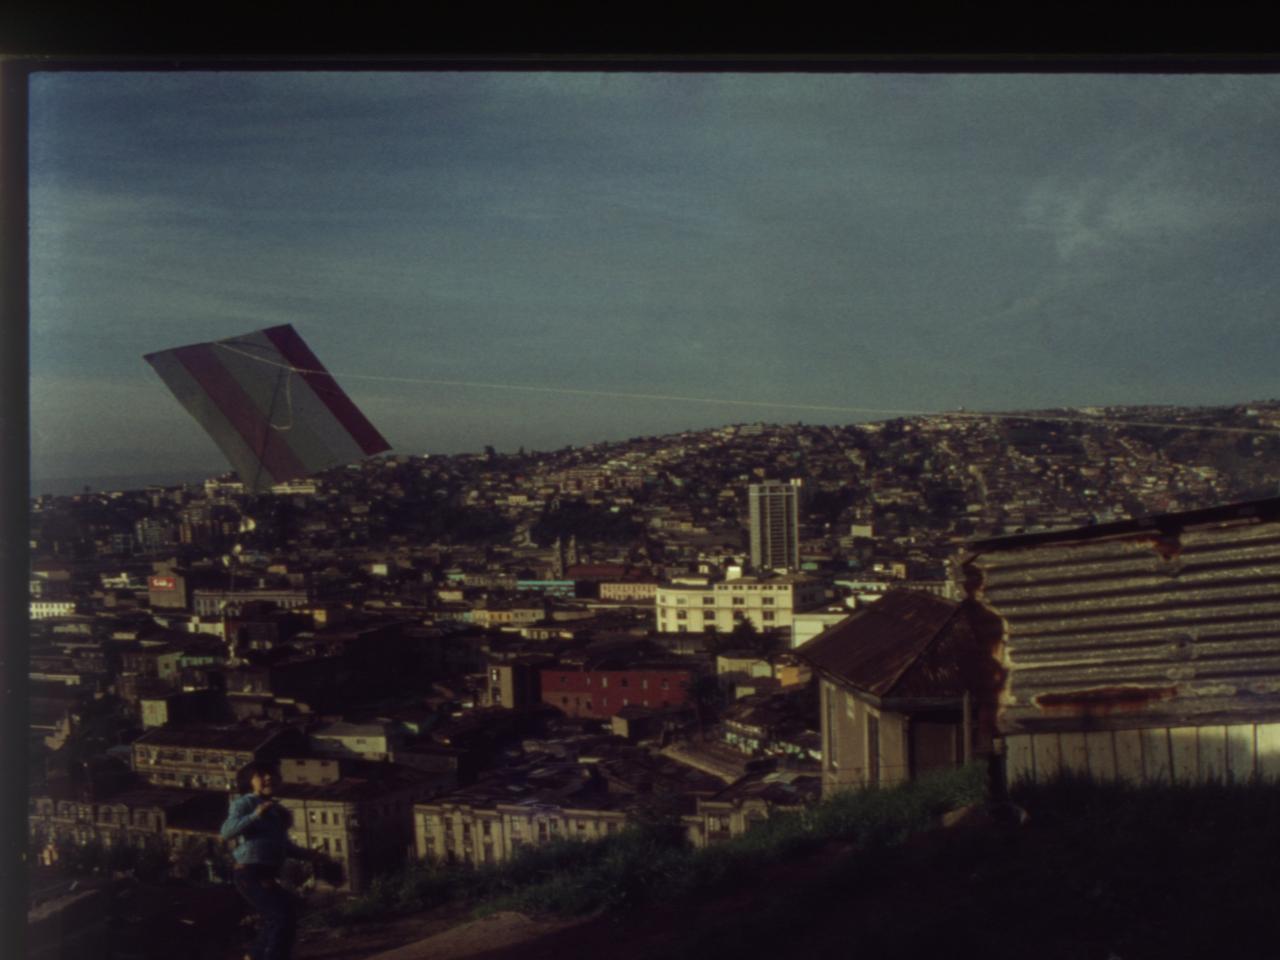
[965,499,1280,733]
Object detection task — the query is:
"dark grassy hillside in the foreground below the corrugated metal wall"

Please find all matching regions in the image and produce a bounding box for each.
[309,772,1280,960]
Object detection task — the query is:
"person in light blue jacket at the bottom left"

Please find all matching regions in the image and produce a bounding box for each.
[221,763,325,960]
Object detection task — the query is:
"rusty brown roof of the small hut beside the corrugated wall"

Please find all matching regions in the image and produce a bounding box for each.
[796,590,961,698]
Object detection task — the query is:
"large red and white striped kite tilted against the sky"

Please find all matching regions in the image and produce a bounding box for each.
[145,324,390,492]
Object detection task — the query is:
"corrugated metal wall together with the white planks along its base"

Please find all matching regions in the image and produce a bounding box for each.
[966,518,1280,780]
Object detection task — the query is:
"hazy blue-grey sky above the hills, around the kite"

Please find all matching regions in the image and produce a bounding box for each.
[29,70,1280,480]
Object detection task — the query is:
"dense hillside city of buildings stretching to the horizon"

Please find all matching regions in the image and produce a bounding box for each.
[29,402,1280,955]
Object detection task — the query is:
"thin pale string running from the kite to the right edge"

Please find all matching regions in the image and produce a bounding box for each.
[212,340,1280,435]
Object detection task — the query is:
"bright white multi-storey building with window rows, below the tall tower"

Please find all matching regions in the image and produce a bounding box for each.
[657,573,826,634]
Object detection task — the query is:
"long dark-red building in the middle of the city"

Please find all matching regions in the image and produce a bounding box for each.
[541,664,695,719]
